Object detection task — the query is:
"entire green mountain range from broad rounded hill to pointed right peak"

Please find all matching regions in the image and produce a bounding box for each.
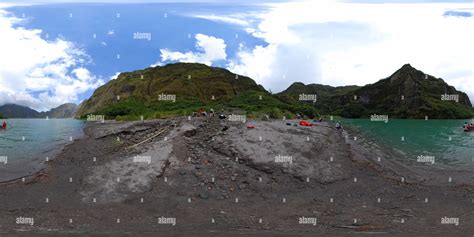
[76,63,473,120]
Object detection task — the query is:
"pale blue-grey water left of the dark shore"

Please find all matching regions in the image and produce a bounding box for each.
[0,119,84,163]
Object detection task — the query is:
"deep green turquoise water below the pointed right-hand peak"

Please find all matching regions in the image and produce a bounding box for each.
[342,119,474,166]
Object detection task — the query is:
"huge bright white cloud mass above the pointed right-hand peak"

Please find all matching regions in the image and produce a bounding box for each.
[228,1,474,101]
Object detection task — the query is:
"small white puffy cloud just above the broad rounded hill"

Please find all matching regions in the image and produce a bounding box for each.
[160,34,227,65]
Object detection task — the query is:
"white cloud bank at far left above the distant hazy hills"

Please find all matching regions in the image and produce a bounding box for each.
[0,9,103,111]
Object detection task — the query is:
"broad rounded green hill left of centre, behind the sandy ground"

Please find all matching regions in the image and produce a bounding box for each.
[77,63,318,119]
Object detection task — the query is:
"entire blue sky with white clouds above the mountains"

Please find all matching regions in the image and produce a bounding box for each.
[0,0,474,111]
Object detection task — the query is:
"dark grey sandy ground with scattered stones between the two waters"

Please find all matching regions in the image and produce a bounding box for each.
[0,118,474,236]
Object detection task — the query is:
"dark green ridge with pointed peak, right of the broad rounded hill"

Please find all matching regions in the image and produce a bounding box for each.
[278,64,474,118]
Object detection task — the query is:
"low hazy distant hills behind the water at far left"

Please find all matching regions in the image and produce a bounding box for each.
[0,103,78,118]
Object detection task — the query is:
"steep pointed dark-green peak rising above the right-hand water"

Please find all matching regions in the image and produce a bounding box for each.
[350,64,472,118]
